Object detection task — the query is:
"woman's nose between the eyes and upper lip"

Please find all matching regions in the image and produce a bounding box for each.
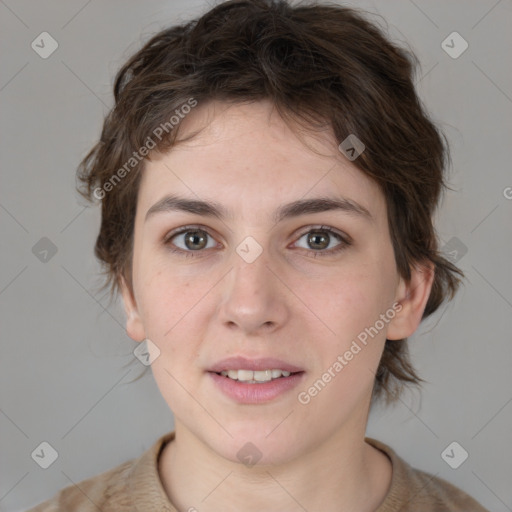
[218,247,289,336]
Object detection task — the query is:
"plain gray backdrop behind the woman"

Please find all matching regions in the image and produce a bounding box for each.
[0,0,512,512]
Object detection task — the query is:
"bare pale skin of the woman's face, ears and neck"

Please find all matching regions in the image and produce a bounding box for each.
[121,101,433,512]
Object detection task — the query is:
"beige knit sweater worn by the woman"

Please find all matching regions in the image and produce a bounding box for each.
[28,432,489,512]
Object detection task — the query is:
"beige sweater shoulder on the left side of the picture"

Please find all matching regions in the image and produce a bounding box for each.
[27,432,174,512]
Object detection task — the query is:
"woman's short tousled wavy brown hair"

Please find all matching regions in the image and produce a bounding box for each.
[78,0,463,402]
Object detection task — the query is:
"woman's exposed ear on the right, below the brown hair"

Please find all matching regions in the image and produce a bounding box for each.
[386,262,434,340]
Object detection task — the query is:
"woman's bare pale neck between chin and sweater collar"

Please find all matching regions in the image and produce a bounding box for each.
[159,422,392,512]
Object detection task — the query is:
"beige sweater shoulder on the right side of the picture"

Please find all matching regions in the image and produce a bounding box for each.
[366,438,489,512]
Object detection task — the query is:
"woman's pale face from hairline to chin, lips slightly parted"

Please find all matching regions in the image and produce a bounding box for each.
[123,102,429,464]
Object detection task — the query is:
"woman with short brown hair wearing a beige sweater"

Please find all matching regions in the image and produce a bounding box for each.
[28,0,485,512]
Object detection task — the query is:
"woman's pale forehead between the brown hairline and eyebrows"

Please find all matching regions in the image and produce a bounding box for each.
[138,101,385,224]
